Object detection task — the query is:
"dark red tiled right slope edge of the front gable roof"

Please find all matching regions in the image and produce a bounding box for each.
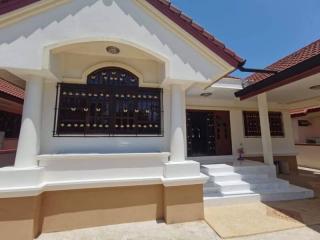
[146,0,245,68]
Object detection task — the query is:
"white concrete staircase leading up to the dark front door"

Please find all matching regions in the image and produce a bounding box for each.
[201,161,314,206]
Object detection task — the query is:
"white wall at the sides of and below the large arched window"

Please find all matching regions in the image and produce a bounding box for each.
[40,83,171,154]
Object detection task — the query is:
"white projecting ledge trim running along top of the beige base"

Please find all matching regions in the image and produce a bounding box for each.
[0,152,208,198]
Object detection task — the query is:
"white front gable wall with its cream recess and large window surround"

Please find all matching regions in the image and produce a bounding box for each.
[0,0,232,154]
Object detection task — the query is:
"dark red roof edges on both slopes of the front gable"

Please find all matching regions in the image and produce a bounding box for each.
[0,0,244,68]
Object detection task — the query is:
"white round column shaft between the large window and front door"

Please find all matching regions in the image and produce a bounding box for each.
[170,85,186,162]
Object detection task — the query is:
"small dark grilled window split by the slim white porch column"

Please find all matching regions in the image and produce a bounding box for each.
[243,111,284,137]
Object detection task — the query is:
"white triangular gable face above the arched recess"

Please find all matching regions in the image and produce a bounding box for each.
[0,0,225,81]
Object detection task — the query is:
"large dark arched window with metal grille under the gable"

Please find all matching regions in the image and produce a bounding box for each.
[54,67,162,136]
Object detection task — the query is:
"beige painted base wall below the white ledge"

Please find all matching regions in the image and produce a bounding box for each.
[0,184,203,240]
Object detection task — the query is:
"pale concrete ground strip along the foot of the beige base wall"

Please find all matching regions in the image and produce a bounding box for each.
[38,221,220,240]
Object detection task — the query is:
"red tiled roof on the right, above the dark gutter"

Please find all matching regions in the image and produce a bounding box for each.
[244,39,320,85]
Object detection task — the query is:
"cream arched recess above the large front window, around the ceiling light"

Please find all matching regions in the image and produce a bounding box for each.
[49,41,166,86]
